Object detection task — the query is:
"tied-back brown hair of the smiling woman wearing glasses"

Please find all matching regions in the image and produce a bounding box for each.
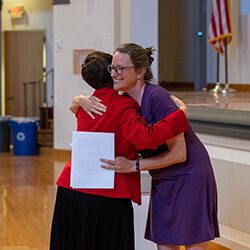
[115,43,155,81]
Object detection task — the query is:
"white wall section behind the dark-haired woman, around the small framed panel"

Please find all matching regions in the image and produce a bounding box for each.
[53,0,115,149]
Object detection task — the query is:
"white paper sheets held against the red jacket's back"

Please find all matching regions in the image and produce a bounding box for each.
[70,131,115,189]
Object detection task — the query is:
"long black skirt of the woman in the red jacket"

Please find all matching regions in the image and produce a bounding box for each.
[50,187,134,250]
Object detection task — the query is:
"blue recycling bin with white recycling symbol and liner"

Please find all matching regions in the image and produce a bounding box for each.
[8,117,40,155]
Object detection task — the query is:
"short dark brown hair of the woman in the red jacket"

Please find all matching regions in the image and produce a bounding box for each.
[81,51,113,89]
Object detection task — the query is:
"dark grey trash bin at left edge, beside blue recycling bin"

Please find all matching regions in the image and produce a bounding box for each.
[0,116,11,152]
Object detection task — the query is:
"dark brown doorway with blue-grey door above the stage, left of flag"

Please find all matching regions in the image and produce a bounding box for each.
[158,0,207,90]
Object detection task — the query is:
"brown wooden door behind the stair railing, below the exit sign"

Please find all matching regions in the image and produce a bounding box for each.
[4,31,45,116]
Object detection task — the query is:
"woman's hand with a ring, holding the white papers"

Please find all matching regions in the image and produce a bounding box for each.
[100,156,136,173]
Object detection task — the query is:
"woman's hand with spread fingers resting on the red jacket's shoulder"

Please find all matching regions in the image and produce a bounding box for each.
[70,95,106,119]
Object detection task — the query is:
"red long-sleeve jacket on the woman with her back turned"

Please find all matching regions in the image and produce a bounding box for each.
[57,88,188,204]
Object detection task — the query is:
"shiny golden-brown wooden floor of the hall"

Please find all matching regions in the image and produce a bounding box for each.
[0,148,232,250]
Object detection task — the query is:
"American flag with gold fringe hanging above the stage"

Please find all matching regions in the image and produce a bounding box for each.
[208,0,232,55]
